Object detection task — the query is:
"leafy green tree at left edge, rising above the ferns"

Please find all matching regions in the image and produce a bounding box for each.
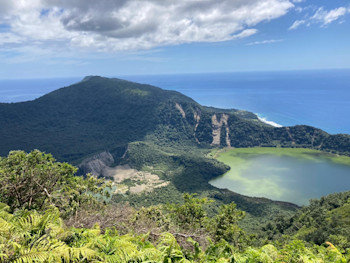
[0,150,108,216]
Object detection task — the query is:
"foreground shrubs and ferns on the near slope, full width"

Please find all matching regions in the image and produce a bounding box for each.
[0,151,350,263]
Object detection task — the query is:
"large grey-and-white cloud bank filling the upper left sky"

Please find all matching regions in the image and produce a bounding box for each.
[0,0,294,52]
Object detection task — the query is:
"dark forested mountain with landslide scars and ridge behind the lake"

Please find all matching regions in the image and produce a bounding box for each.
[0,76,350,164]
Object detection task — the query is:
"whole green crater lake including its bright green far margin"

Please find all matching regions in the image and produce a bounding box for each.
[209,148,350,205]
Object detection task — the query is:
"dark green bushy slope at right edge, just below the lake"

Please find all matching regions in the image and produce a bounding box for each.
[262,191,350,252]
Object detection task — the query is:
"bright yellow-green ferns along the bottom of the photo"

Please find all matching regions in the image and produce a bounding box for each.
[0,206,349,263]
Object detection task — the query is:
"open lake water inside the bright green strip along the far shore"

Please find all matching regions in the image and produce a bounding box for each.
[210,154,350,205]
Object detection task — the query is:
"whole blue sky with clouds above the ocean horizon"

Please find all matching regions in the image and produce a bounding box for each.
[0,0,350,79]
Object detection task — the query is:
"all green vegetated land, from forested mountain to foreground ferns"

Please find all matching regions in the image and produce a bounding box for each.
[0,77,350,262]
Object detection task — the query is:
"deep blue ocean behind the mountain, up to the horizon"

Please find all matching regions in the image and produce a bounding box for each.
[0,70,350,134]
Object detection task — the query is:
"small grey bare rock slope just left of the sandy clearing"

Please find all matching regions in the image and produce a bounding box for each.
[79,151,114,176]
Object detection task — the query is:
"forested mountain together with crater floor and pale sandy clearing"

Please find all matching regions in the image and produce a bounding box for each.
[0,76,350,227]
